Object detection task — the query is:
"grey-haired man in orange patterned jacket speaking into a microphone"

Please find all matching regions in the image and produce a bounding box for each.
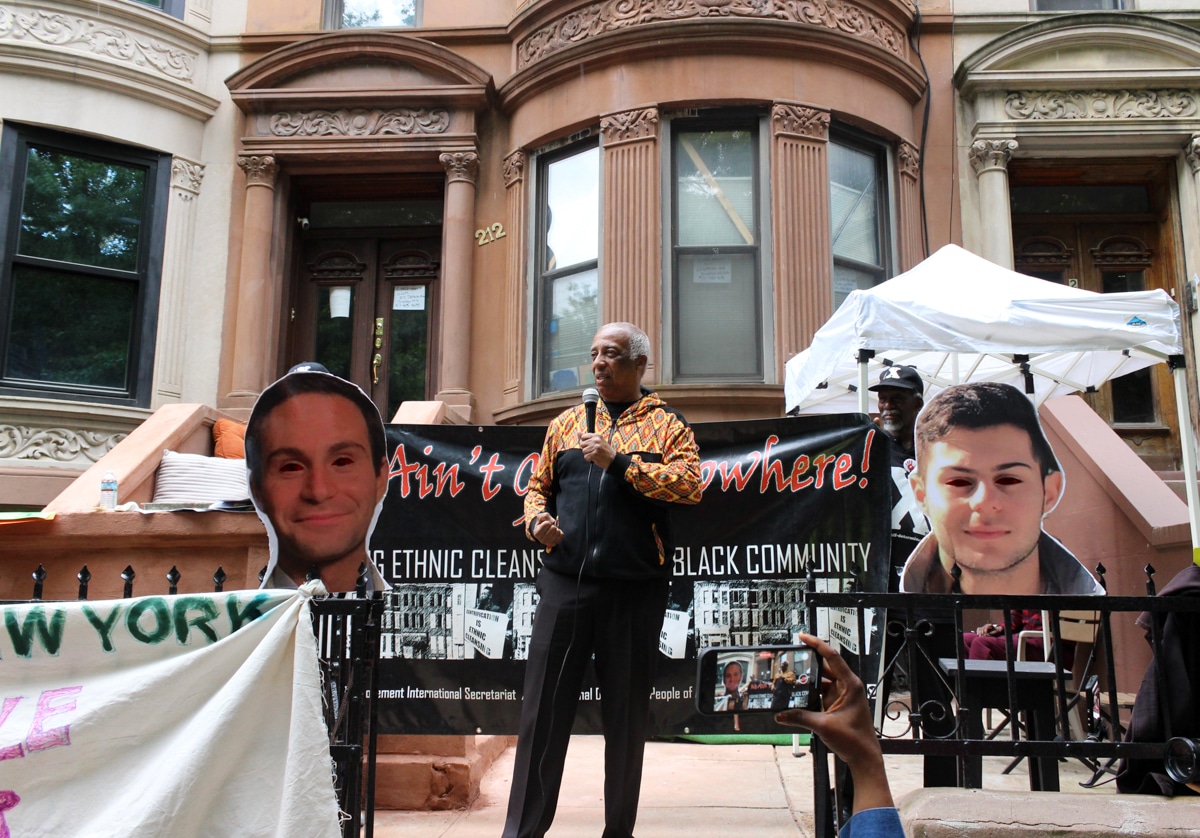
[504,323,701,838]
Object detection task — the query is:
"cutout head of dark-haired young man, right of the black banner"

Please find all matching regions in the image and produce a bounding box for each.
[901,383,1098,594]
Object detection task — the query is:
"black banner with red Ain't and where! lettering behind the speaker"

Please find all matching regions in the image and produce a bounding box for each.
[371,414,890,735]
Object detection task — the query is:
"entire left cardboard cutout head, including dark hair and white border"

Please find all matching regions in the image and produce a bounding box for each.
[246,364,388,592]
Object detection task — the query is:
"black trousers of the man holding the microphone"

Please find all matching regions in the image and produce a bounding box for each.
[504,568,668,838]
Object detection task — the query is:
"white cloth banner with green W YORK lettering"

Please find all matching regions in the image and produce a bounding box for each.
[0,582,340,838]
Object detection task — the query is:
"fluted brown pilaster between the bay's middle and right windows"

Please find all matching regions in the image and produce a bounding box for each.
[770,102,833,364]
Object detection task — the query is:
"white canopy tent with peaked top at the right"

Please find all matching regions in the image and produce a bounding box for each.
[784,245,1200,555]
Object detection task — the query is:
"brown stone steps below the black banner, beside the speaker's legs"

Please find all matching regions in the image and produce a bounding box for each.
[376,736,516,812]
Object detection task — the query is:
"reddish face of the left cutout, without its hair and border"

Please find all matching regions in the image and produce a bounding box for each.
[254,393,388,591]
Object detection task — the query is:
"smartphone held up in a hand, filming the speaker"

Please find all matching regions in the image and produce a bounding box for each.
[696,645,821,716]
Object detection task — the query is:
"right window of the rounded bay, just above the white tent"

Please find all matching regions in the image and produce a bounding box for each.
[829,134,889,310]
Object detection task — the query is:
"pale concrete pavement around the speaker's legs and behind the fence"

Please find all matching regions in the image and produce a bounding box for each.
[374,736,1114,838]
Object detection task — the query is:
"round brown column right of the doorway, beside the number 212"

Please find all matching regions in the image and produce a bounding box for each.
[437,151,479,421]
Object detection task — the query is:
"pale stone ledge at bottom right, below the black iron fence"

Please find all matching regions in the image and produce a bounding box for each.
[900,789,1198,838]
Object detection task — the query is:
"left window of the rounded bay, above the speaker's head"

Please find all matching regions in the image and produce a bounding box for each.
[534,140,600,394]
